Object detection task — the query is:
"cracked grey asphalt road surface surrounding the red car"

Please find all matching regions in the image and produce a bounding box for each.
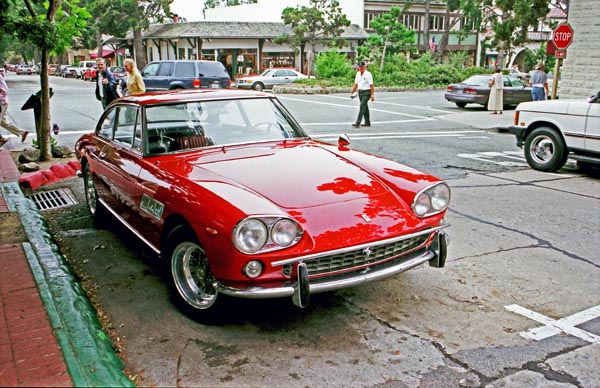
[4,73,600,388]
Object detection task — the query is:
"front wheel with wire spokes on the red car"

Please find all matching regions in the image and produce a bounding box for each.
[163,225,218,321]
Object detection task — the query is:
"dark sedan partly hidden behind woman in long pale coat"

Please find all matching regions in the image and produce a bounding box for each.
[444,74,531,108]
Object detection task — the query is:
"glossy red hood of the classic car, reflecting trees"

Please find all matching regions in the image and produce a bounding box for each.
[168,142,406,209]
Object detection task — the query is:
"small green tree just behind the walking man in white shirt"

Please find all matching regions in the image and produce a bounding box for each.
[357,6,415,70]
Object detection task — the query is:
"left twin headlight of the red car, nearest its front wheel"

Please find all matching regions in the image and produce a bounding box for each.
[232,216,304,254]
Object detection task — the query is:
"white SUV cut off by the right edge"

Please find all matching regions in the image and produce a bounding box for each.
[508,92,600,171]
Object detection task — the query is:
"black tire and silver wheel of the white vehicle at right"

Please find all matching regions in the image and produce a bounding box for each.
[525,127,568,172]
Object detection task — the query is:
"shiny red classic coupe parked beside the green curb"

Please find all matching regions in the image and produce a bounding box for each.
[75,89,450,319]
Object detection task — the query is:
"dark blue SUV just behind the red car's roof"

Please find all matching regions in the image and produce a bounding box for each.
[142,60,231,91]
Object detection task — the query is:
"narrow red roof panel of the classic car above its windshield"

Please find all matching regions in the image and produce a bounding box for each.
[119,89,273,105]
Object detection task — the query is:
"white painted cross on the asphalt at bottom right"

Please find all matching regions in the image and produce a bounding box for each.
[504,304,600,343]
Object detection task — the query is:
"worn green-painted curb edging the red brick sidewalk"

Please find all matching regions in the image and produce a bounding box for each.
[2,183,135,387]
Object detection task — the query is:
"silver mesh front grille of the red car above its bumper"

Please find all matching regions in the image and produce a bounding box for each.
[283,234,429,277]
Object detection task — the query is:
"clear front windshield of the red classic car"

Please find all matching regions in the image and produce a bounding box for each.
[145,98,307,154]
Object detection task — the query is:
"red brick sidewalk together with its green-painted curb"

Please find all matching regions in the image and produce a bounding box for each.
[0,149,133,387]
